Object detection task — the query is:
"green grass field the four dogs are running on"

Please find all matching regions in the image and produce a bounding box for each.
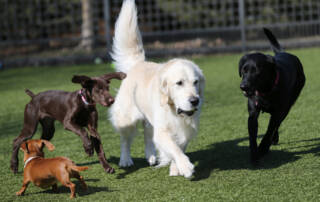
[0,48,320,202]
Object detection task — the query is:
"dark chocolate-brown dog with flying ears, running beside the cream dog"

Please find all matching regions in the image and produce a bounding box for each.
[11,72,126,173]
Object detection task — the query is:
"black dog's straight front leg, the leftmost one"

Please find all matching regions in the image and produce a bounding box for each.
[248,99,260,164]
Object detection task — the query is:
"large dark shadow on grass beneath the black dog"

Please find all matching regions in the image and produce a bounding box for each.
[187,137,320,181]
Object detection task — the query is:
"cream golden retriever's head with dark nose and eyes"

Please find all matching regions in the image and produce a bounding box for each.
[161,60,204,116]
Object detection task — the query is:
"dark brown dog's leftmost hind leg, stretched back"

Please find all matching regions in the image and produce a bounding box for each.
[10,103,38,173]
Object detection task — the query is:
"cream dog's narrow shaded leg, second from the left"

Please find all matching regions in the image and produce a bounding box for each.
[144,121,157,166]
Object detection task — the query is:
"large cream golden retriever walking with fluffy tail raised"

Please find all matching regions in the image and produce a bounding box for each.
[110,0,205,178]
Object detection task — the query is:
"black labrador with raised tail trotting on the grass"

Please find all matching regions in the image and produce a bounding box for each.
[239,28,305,163]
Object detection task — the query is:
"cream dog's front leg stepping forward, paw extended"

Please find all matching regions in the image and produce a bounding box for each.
[154,129,194,178]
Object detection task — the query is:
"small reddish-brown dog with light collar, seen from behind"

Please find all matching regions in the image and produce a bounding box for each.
[16,140,88,198]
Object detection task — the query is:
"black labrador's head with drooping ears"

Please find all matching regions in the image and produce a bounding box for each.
[239,53,276,97]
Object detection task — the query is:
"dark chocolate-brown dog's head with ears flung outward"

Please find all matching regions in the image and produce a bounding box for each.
[72,72,126,107]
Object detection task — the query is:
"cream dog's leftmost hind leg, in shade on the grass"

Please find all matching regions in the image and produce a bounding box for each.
[119,125,137,167]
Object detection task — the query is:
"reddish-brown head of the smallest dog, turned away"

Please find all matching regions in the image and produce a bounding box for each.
[20,140,54,161]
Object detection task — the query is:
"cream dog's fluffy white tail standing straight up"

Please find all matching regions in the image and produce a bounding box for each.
[111,0,145,73]
